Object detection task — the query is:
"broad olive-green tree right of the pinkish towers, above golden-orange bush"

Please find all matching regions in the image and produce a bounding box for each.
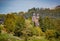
[40,16,55,31]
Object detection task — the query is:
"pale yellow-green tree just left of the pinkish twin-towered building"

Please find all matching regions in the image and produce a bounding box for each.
[21,19,33,36]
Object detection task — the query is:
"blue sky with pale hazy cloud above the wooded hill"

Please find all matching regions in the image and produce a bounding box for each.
[0,0,60,14]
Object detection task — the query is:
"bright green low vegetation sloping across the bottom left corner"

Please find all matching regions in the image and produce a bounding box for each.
[0,33,23,41]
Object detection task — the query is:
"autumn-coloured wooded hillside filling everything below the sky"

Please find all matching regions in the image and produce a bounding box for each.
[0,5,60,41]
